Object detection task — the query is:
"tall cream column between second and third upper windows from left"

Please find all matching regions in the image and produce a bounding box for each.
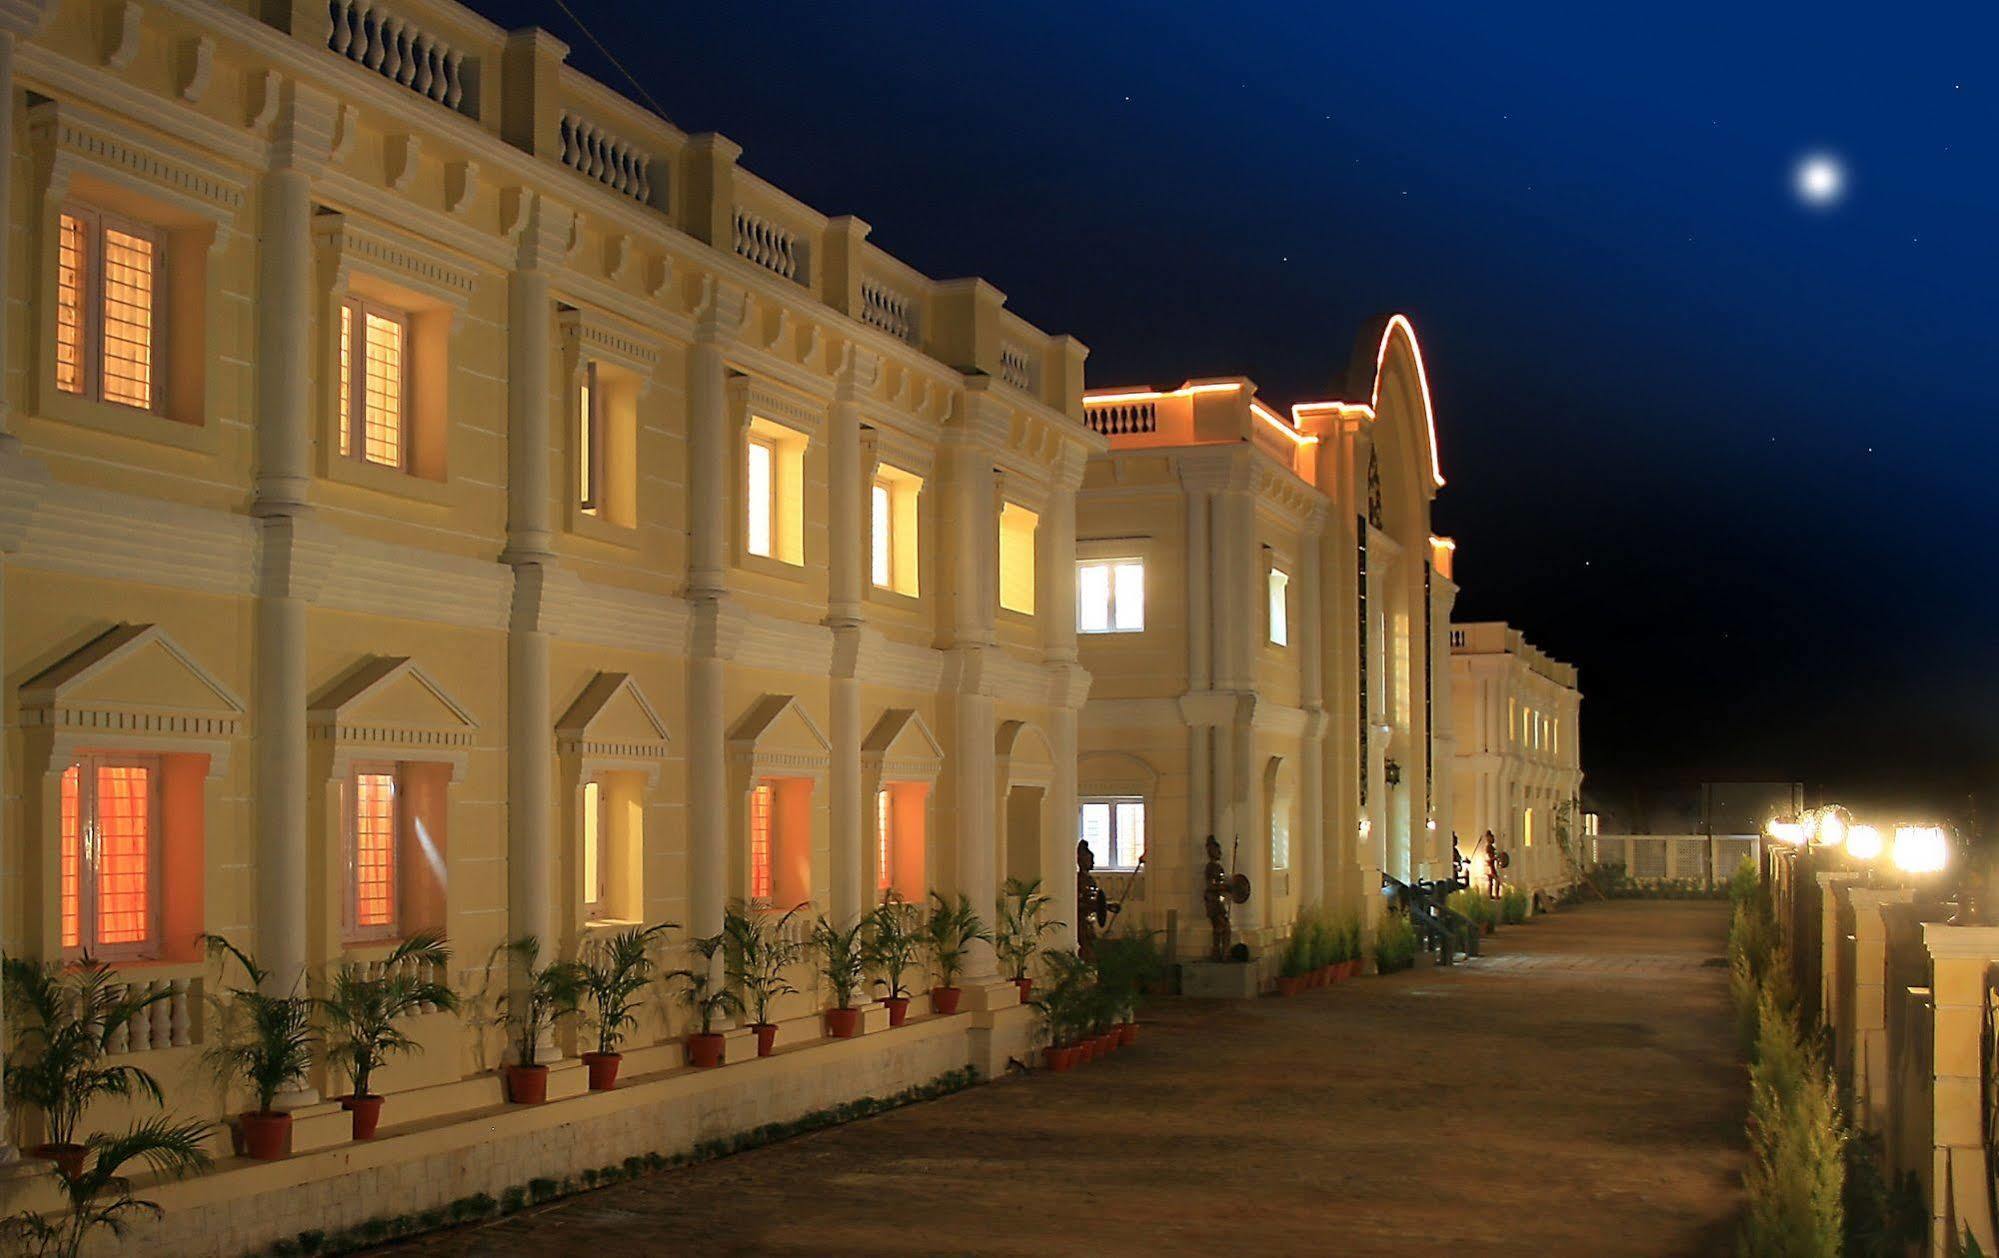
[502,198,568,1060]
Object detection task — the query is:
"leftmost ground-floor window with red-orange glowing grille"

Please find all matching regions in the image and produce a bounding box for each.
[58,756,160,956]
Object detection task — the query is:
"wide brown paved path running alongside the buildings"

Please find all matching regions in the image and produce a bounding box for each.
[381,902,1747,1258]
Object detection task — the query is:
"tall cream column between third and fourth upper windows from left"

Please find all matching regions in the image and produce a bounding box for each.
[686,286,746,936]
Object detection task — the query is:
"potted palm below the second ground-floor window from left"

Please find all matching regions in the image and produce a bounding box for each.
[318,930,458,1140]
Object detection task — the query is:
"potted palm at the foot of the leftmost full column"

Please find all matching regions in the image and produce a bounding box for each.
[202,934,318,1162]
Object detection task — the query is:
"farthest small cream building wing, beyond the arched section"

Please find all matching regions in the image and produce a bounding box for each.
[1451,620,1589,902]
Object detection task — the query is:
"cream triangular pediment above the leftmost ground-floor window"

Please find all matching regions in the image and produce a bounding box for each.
[20,624,244,734]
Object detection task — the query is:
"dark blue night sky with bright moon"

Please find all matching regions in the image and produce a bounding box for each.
[476,0,1999,812]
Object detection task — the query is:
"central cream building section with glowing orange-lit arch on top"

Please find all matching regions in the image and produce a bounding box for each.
[1075,316,1455,964]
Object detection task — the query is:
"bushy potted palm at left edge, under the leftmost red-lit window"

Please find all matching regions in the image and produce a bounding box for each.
[0,954,168,1178]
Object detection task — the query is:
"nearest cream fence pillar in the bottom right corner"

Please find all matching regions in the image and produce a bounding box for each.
[1923,922,1999,1254]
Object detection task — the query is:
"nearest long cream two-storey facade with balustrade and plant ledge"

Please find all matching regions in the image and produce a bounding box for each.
[0,0,1105,1252]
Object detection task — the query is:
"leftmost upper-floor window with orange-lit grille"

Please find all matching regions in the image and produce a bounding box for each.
[56,206,166,410]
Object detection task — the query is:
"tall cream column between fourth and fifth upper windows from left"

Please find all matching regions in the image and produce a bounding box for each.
[826,358,874,922]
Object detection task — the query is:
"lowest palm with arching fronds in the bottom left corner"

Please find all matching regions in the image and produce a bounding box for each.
[0,1116,208,1258]
